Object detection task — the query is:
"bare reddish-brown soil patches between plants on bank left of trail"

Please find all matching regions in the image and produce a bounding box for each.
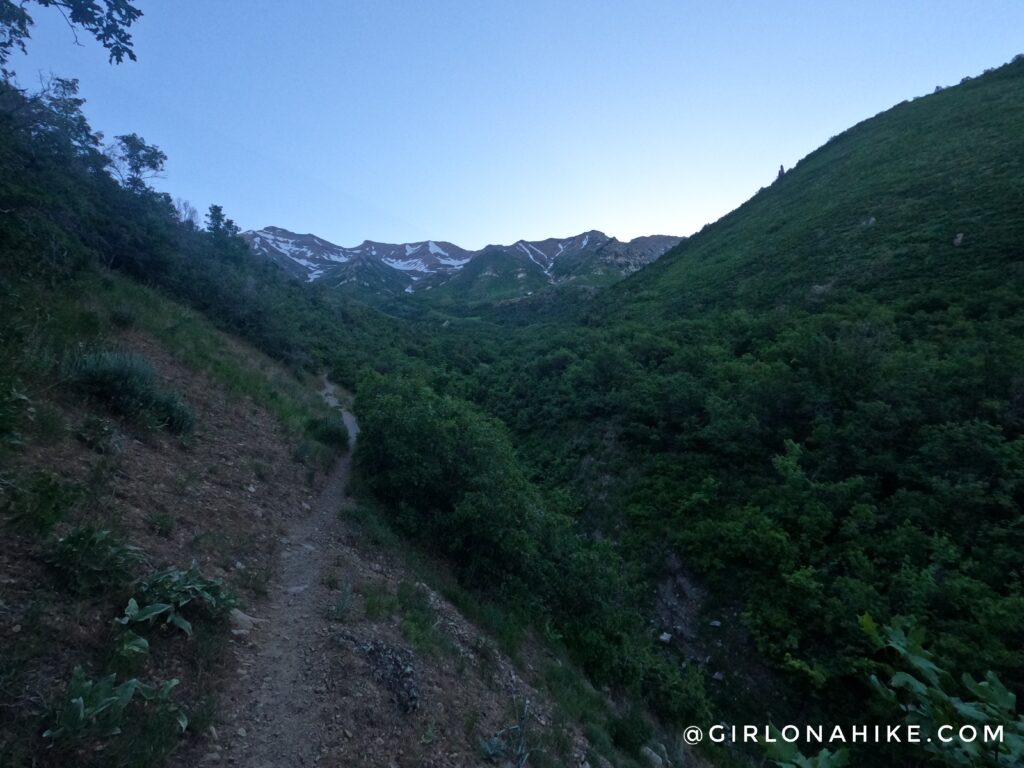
[0,332,315,765]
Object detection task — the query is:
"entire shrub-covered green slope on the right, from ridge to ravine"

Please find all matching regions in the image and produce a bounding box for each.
[450,60,1024,764]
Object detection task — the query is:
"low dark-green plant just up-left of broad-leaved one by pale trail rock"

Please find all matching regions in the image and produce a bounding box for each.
[46,526,145,594]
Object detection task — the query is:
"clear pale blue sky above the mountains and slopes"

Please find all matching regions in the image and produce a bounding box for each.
[13,0,1024,248]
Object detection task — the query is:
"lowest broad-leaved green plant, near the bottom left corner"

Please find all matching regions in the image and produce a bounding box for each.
[43,667,188,743]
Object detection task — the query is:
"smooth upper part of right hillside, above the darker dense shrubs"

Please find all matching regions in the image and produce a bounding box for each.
[605,59,1024,318]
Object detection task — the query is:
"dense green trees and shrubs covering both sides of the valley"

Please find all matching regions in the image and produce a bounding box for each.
[0,16,1024,760]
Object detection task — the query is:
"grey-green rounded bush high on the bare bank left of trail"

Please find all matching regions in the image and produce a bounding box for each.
[69,352,195,434]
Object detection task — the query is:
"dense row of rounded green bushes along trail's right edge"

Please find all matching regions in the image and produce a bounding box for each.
[355,374,708,722]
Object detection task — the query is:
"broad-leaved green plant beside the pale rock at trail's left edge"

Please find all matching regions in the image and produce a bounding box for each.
[116,561,237,637]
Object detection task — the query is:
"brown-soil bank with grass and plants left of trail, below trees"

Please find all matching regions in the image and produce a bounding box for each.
[0,260,352,766]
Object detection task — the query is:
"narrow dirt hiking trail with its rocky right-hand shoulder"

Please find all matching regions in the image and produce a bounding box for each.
[198,379,552,768]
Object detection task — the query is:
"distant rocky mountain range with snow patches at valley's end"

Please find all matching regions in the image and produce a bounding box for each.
[242,226,683,301]
